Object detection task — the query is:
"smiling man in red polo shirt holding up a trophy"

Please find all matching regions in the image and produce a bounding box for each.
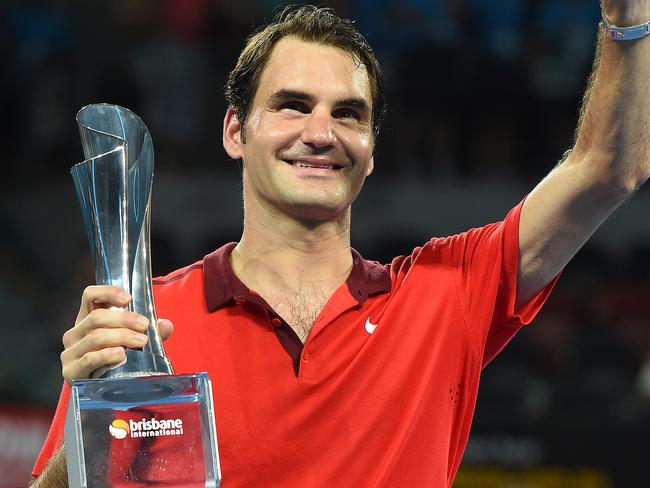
[34,0,650,487]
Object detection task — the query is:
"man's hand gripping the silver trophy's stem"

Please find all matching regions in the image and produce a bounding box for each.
[61,286,173,382]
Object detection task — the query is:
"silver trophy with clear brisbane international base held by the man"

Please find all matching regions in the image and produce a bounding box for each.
[65,104,221,488]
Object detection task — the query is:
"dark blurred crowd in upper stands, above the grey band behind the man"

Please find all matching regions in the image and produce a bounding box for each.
[0,0,599,183]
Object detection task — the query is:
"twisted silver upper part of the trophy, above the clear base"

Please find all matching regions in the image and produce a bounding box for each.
[70,104,173,378]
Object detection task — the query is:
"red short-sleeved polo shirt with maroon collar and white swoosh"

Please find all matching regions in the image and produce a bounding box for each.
[35,204,553,488]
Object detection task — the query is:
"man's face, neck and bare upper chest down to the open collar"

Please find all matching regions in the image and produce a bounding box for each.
[223,36,374,341]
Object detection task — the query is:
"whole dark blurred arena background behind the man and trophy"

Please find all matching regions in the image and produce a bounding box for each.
[0,0,650,488]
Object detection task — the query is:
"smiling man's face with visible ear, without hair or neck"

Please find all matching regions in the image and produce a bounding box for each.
[224,38,374,221]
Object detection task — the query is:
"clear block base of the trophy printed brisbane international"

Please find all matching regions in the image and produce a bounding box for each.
[65,373,221,488]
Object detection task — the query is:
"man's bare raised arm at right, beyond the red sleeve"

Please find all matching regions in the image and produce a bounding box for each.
[517,0,650,306]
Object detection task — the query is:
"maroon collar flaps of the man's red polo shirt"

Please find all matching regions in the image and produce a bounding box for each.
[203,242,391,312]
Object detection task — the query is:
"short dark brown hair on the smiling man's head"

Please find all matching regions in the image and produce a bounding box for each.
[225,5,386,139]
